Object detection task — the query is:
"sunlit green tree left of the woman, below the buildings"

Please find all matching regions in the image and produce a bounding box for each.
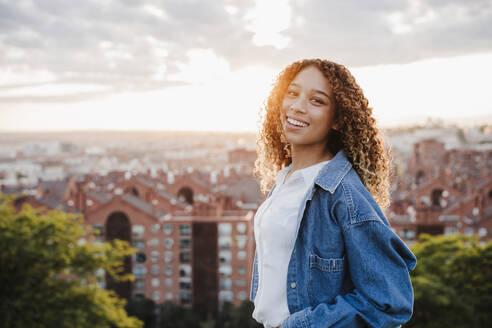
[0,194,142,328]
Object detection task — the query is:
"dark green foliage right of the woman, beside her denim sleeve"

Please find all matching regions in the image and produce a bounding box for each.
[405,235,492,328]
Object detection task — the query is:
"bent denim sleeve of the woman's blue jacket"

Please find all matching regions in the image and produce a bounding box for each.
[282,218,416,328]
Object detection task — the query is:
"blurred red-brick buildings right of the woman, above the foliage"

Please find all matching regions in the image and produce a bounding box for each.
[389,139,492,244]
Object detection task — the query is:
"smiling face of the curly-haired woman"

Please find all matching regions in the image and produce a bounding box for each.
[280,66,335,146]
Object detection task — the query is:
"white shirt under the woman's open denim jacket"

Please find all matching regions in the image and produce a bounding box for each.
[253,161,329,328]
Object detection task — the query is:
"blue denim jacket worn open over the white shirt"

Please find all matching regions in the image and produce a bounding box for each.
[250,150,416,328]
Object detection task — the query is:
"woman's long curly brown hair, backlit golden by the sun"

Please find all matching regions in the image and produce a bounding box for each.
[254,59,391,208]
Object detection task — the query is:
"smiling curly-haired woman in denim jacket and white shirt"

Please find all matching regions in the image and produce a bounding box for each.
[250,59,416,328]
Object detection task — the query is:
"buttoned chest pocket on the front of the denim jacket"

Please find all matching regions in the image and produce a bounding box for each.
[308,254,346,306]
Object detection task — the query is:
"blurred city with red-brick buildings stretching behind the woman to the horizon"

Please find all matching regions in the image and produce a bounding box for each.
[0,124,492,313]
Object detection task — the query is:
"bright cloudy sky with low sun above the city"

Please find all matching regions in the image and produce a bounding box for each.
[0,0,492,132]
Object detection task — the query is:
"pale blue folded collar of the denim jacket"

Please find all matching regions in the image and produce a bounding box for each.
[314,149,352,194]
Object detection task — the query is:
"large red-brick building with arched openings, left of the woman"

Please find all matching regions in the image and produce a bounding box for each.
[9,164,263,313]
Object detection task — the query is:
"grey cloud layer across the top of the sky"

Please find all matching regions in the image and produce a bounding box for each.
[0,0,492,103]
